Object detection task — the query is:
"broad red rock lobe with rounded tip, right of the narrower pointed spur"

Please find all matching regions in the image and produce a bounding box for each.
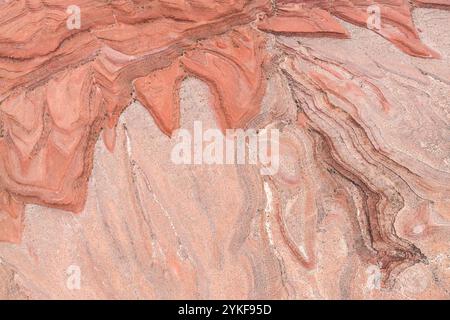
[181,28,266,128]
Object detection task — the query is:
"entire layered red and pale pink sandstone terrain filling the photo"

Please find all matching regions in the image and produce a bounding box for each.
[0,0,450,299]
